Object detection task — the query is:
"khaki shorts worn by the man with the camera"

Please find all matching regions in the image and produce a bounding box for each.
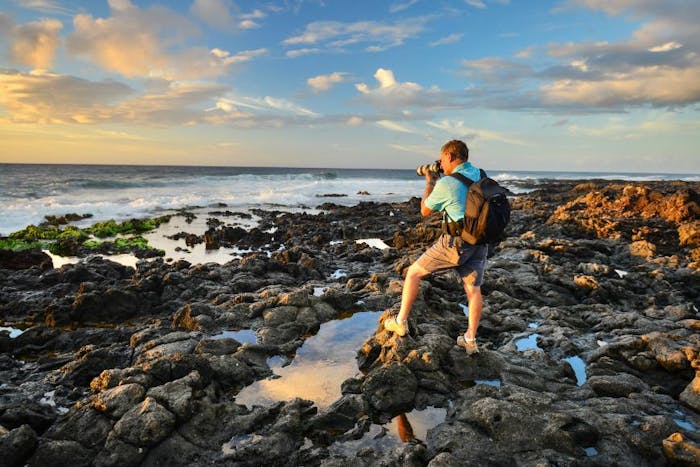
[416,234,488,287]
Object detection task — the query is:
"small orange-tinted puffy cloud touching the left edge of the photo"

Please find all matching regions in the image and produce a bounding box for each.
[0,13,63,69]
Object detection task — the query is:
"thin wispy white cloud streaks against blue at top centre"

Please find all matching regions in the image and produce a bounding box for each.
[282,17,431,51]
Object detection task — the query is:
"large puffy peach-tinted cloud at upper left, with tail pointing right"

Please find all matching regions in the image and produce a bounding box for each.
[67,0,266,80]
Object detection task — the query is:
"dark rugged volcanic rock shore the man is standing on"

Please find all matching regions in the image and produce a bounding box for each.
[0,180,700,466]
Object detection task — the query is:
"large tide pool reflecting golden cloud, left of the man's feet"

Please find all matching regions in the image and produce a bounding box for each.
[236,312,380,408]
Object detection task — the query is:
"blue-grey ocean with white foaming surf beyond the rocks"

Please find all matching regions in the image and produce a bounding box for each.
[0,164,700,236]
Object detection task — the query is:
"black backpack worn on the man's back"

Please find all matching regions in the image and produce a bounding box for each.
[450,169,510,245]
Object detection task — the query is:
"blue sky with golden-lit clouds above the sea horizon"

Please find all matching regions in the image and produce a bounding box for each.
[0,0,700,173]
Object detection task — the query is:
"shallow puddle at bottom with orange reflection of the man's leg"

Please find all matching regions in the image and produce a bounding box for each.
[328,407,447,456]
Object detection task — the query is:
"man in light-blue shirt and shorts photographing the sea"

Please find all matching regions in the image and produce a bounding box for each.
[384,140,488,355]
